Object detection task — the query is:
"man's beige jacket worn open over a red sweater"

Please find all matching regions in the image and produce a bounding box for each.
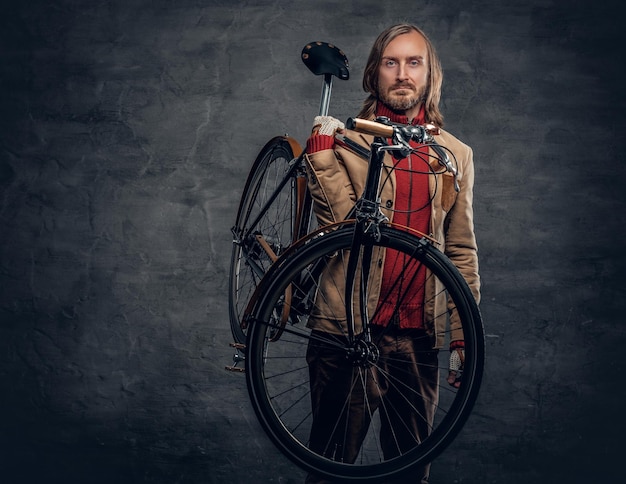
[307,126,480,348]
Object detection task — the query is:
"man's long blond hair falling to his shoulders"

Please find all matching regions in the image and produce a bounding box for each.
[358,23,443,127]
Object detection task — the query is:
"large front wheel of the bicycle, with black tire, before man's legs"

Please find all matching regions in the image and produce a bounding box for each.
[246,226,484,482]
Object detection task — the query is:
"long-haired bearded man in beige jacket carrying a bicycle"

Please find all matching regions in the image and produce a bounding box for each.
[307,24,480,483]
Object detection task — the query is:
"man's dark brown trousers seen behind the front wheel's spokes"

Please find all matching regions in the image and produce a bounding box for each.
[306,327,439,484]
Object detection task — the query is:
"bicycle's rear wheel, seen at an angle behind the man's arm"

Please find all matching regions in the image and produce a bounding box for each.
[228,137,310,344]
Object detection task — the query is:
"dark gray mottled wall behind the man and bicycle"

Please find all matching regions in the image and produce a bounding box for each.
[0,0,626,484]
